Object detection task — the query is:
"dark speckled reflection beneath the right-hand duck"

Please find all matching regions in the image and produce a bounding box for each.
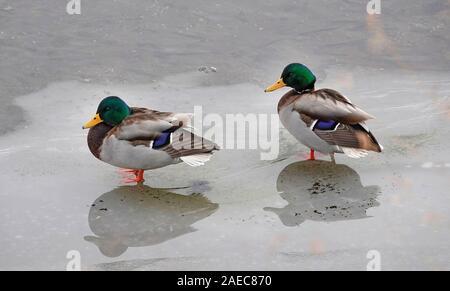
[264,161,380,226]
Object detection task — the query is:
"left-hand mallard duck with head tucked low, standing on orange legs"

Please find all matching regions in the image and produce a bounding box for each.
[83,96,218,183]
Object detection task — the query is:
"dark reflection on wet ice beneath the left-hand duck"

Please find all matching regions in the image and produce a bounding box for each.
[85,185,218,257]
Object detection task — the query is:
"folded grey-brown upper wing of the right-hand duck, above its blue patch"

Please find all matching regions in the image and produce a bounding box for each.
[294,89,374,124]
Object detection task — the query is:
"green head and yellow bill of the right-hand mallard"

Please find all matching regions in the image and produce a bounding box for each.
[265,63,316,92]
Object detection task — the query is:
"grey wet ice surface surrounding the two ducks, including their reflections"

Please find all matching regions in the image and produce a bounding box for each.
[0,0,450,270]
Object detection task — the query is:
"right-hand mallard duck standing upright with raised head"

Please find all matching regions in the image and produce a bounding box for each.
[265,63,383,161]
